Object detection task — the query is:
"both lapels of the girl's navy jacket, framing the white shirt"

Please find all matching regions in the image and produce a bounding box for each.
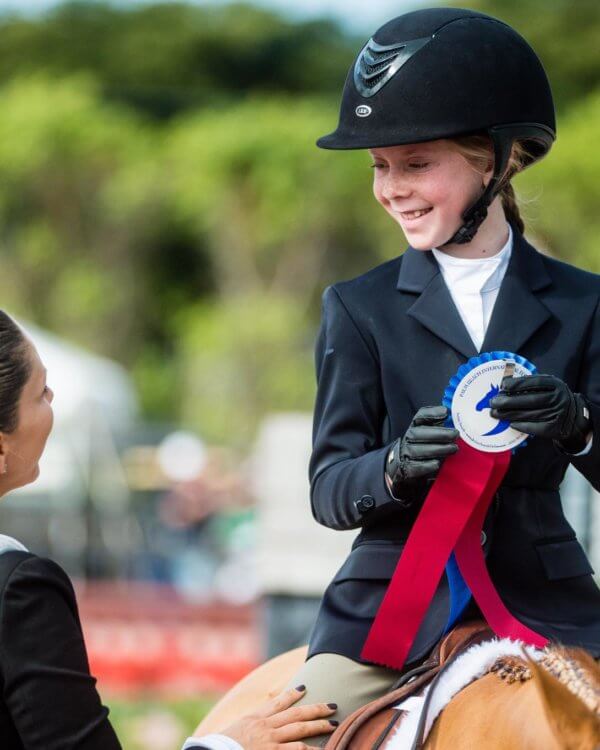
[397,227,552,359]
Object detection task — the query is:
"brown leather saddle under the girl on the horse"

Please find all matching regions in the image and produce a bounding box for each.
[325,620,494,750]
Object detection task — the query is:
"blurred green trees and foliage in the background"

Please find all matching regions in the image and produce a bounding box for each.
[0,0,600,446]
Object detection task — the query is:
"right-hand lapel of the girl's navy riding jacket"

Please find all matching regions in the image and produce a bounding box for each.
[481,232,552,354]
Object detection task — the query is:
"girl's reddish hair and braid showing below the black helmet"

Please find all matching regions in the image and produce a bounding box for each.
[451,134,529,234]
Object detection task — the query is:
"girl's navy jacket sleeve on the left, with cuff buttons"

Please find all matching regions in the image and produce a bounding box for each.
[309,287,396,529]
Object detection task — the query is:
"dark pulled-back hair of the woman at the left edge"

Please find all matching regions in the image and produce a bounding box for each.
[0,310,31,432]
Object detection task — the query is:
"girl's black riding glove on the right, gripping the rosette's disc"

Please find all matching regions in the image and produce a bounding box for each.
[490,375,592,453]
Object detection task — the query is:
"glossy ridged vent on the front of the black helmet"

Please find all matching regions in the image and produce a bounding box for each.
[354,36,433,98]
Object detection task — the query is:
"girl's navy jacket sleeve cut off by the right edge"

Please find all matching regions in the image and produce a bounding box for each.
[569,294,600,492]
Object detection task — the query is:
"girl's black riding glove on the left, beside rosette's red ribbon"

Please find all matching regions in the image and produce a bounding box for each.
[386,406,458,505]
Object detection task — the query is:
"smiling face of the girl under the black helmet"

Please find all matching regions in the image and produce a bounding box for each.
[369,140,492,250]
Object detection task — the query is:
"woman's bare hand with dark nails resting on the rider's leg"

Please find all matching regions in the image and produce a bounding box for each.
[194,685,339,750]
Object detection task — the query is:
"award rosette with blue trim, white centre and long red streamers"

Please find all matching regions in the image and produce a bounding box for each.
[361,351,547,669]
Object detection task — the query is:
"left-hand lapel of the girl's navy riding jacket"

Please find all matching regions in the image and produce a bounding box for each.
[397,247,477,359]
